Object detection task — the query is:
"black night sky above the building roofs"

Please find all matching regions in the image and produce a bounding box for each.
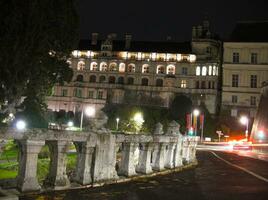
[79,0,268,41]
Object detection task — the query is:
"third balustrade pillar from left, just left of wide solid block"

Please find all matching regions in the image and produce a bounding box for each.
[72,142,95,185]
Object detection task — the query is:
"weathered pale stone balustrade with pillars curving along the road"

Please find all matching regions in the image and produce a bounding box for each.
[0,123,198,192]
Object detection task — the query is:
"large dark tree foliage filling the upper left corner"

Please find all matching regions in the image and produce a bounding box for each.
[0,0,78,124]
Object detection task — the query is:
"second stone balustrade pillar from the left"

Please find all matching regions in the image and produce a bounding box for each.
[45,140,70,189]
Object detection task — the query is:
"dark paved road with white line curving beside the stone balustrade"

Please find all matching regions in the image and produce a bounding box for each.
[20,151,268,200]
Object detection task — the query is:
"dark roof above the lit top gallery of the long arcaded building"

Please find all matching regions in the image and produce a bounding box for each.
[78,40,191,54]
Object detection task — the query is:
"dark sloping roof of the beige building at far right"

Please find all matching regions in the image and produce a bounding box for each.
[227,21,268,42]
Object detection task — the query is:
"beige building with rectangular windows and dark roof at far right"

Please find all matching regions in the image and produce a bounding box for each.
[222,22,268,117]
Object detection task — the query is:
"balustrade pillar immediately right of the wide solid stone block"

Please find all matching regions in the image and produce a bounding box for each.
[118,142,138,176]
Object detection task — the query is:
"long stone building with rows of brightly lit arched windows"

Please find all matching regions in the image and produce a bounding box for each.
[47,21,221,114]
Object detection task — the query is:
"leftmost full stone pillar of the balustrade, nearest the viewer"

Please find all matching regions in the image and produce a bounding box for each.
[17,140,45,192]
